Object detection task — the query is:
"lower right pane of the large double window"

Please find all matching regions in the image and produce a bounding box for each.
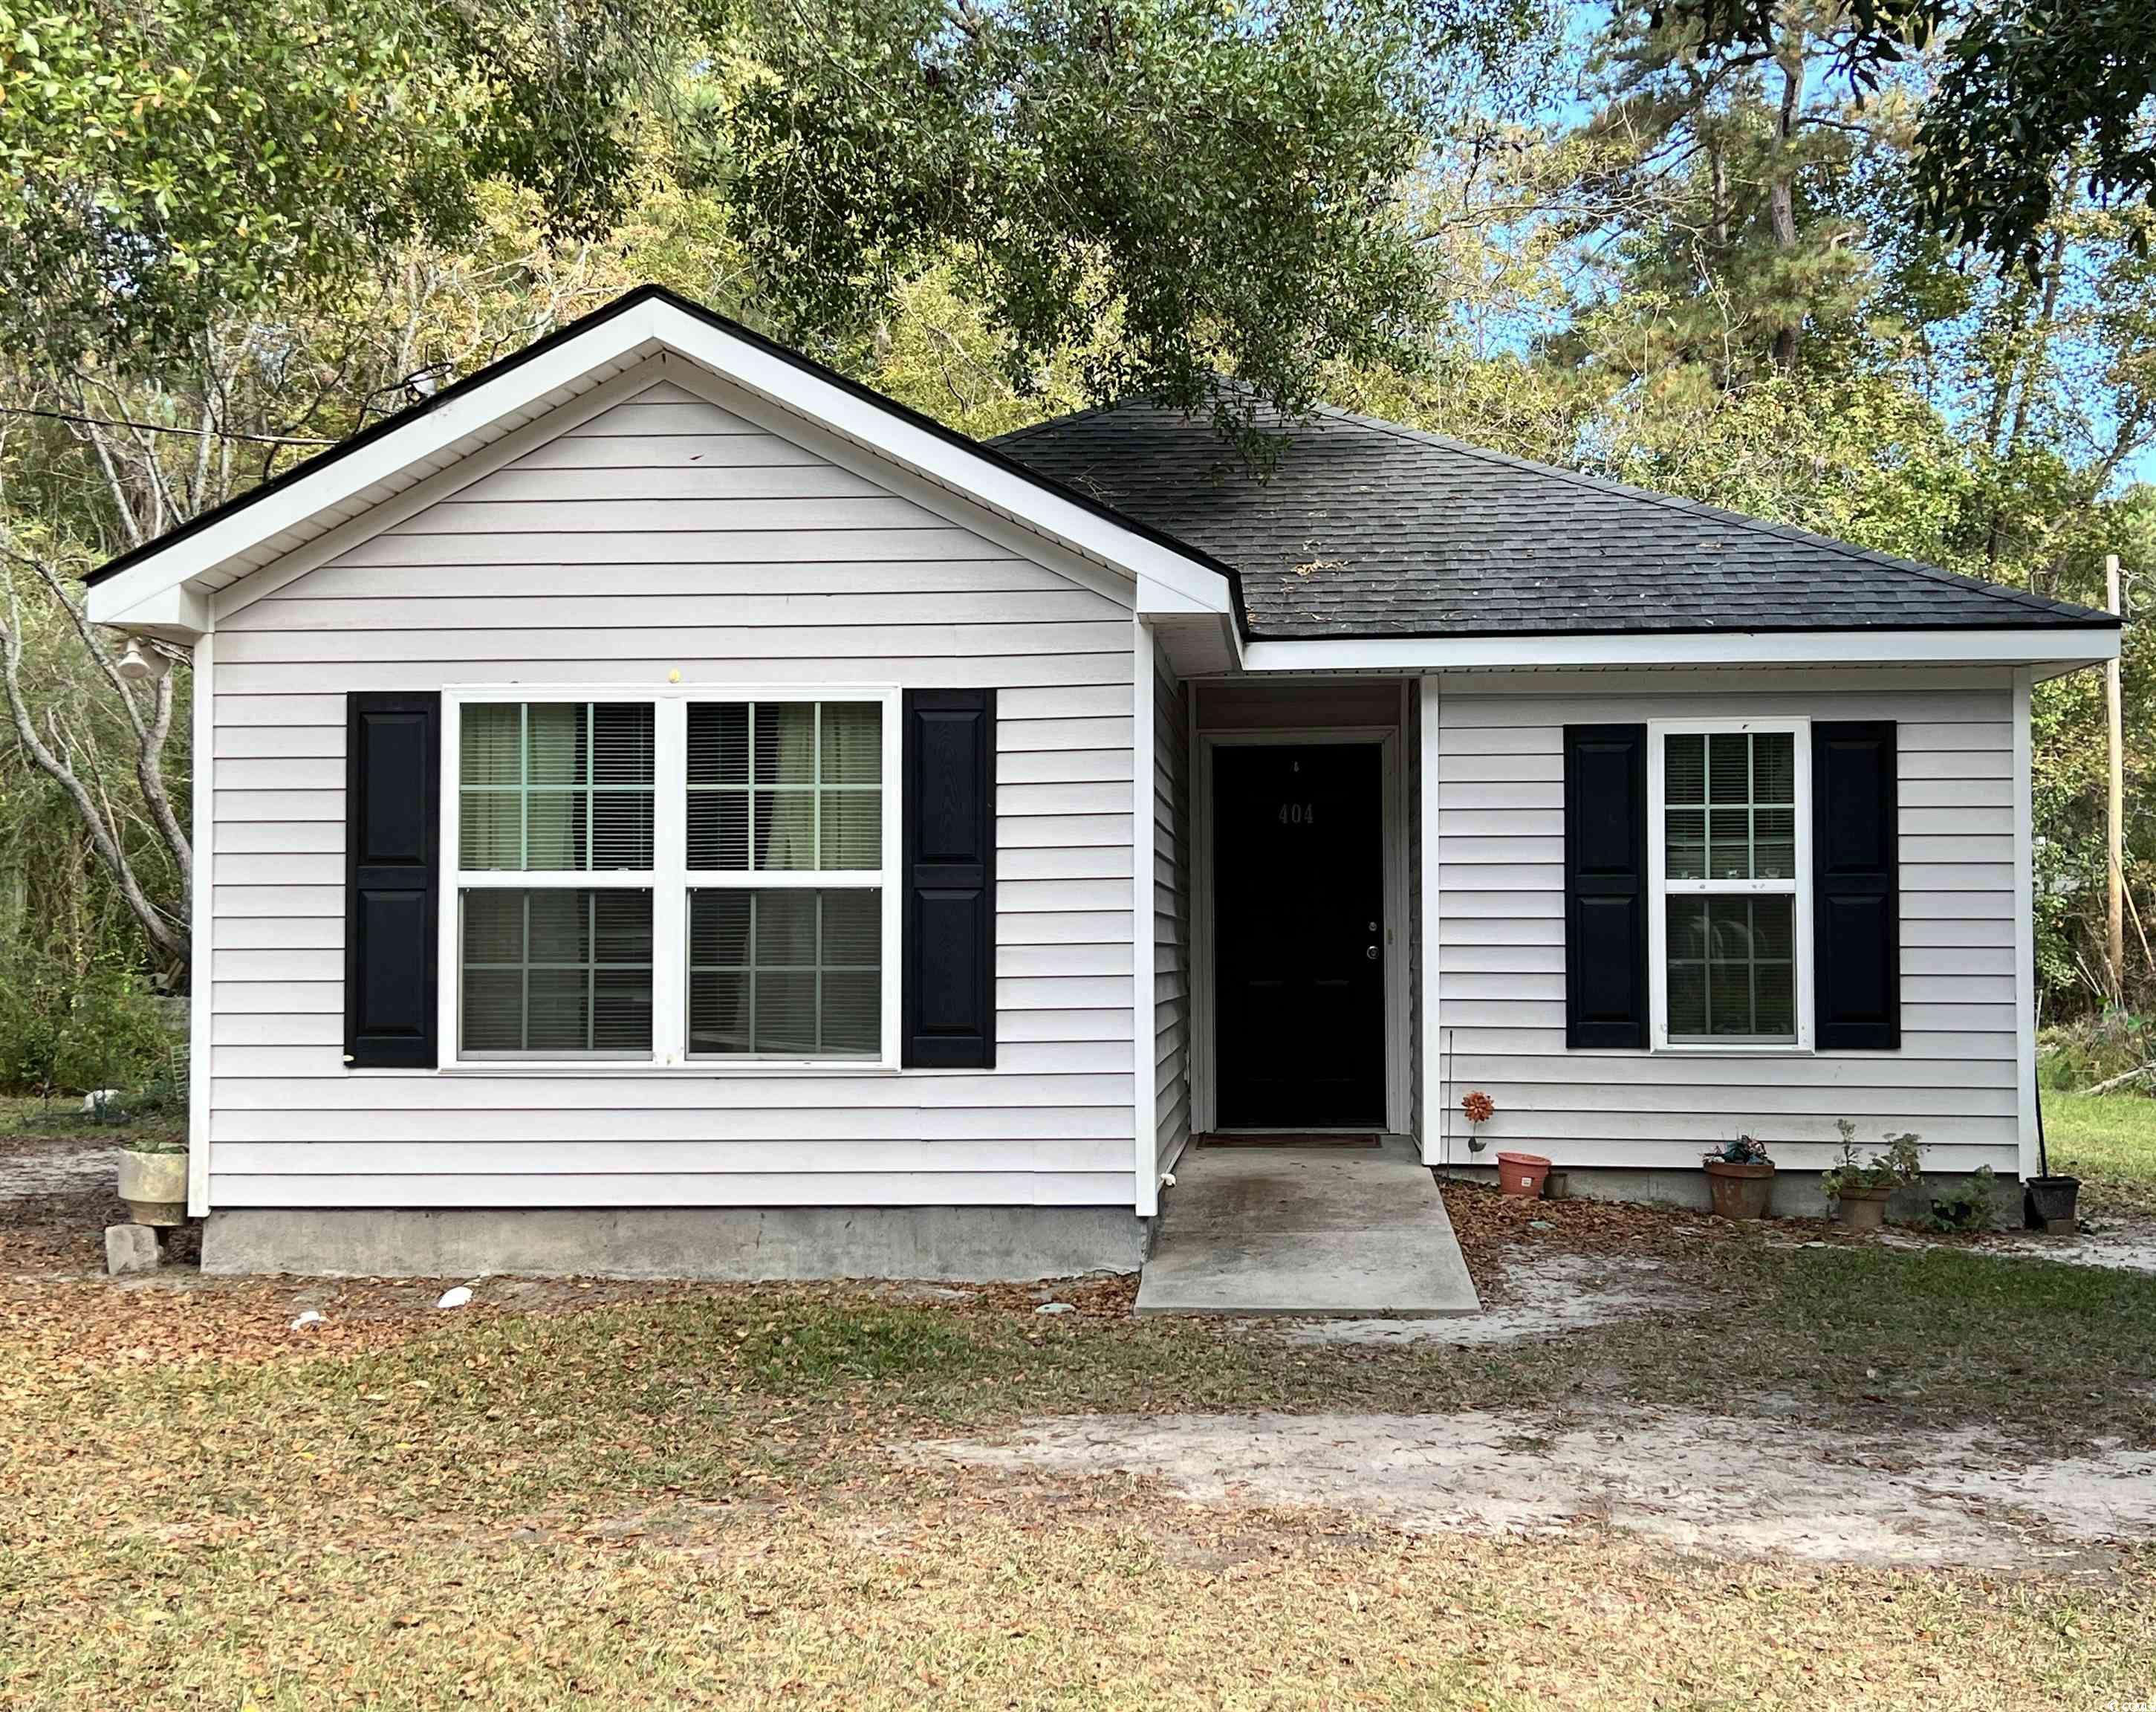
[688,886,884,1059]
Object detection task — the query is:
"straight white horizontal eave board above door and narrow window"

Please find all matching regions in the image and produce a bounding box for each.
[1242,623,2120,677]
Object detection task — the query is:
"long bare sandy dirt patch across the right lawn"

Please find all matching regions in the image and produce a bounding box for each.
[910,1410,2156,1572]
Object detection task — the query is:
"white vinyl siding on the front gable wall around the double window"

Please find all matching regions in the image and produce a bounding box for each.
[209,380,1134,1207]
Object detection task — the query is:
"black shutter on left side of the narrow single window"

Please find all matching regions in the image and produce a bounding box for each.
[1565,724,1647,1045]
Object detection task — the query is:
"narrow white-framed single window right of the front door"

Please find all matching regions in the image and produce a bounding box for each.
[1647,720,1811,1045]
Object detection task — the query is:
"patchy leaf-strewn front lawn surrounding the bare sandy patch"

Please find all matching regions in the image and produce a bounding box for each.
[0,1190,2156,1708]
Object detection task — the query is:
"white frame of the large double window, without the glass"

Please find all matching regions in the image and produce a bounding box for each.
[438,684,903,1076]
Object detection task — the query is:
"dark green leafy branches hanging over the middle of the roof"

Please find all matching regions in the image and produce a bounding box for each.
[733,0,1539,449]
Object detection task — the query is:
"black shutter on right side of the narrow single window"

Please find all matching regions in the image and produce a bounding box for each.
[1811,720,1902,1052]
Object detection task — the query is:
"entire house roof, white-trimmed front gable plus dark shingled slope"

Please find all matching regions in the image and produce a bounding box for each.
[88,285,2117,669]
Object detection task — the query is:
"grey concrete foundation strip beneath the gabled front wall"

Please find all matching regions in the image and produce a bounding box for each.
[203,1207,1147,1283]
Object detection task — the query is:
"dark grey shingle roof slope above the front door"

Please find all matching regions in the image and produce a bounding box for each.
[994,403,2115,636]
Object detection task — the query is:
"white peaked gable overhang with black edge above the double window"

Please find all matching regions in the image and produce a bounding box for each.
[88,287,1238,641]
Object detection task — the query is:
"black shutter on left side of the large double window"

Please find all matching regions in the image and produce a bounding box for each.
[345,692,442,1069]
